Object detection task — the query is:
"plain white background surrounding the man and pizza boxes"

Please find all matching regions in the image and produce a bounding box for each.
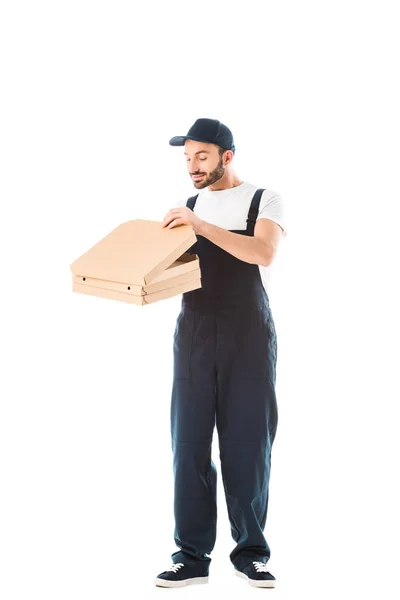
[0,0,400,600]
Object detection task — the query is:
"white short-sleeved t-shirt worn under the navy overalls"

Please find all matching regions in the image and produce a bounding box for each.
[173,181,287,291]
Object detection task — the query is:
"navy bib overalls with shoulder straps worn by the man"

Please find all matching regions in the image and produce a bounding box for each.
[171,189,278,575]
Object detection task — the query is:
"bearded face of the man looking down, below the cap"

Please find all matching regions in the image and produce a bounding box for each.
[184,140,225,190]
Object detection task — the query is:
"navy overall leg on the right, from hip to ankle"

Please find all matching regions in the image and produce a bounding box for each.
[217,309,278,569]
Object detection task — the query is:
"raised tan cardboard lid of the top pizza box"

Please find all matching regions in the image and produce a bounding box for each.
[70,219,197,285]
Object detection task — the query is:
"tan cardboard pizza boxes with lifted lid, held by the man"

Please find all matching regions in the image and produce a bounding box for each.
[70,219,201,306]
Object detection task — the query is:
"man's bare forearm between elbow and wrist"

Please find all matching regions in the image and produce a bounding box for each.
[195,221,269,266]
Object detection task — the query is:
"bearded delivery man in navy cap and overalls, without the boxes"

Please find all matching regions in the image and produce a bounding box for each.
[155,119,286,587]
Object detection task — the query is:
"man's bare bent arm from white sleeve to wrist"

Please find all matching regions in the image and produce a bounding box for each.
[196,218,282,267]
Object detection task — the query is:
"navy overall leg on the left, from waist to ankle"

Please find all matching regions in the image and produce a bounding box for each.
[171,307,217,574]
